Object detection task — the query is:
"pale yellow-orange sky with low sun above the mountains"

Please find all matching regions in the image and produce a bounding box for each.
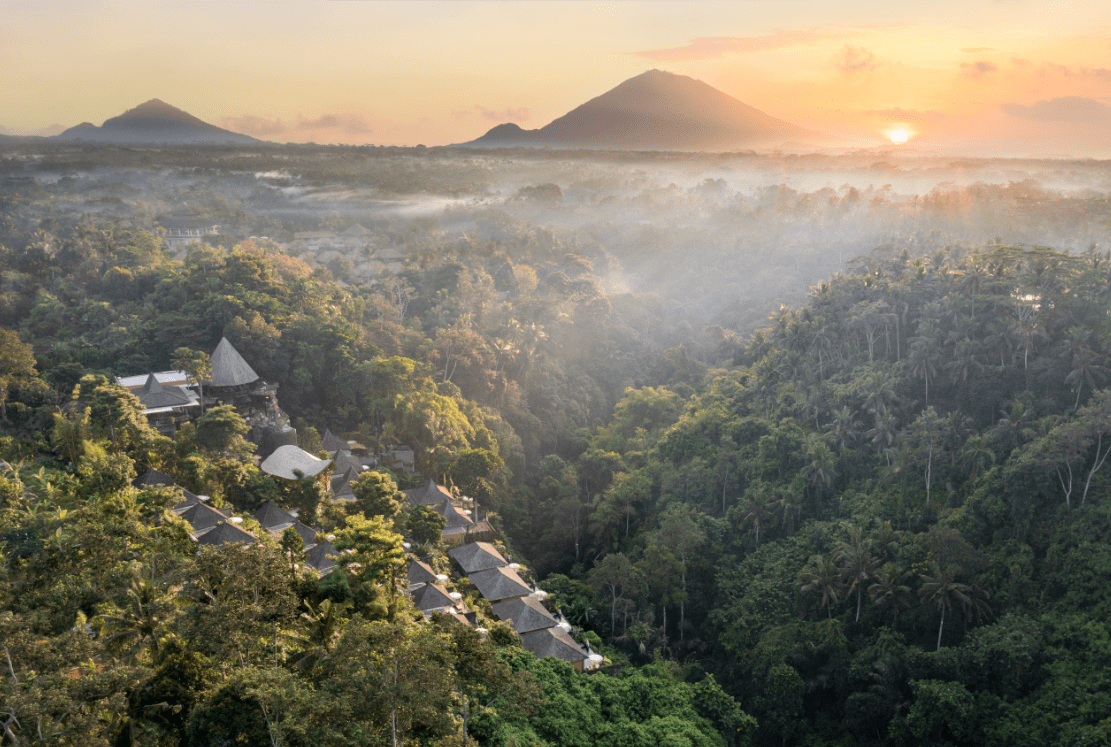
[0,0,1111,157]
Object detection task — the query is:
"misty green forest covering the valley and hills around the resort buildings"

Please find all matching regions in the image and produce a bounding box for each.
[0,142,1111,747]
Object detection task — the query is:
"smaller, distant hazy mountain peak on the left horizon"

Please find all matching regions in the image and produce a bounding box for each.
[57,99,259,145]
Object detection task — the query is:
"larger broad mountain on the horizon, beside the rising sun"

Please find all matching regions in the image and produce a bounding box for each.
[461,70,833,150]
